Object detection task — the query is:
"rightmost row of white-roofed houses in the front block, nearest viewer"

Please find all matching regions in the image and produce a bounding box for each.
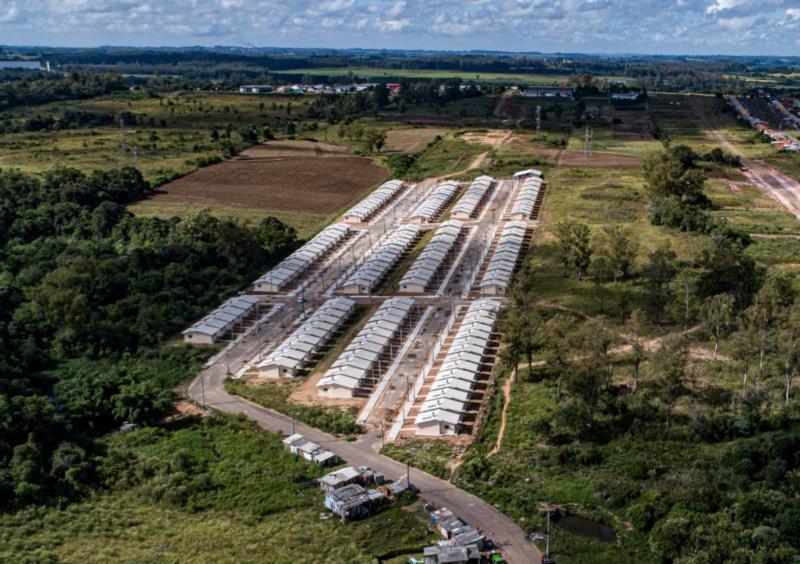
[414,299,501,436]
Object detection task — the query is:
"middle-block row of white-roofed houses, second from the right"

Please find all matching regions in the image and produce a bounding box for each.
[400,219,464,294]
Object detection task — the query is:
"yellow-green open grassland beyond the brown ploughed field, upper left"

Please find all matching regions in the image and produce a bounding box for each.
[0,93,316,182]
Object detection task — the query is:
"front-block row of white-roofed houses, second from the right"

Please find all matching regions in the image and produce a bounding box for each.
[317,298,420,398]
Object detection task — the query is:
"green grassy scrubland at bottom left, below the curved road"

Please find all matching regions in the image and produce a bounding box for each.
[0,416,431,563]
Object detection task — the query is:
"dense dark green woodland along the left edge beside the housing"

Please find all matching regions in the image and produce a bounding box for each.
[0,168,296,509]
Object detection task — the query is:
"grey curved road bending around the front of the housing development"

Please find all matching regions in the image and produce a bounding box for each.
[189,328,542,564]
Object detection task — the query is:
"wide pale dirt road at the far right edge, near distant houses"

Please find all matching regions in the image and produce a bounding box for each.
[689,96,800,219]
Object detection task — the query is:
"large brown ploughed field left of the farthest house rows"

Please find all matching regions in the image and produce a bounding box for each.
[150,147,394,213]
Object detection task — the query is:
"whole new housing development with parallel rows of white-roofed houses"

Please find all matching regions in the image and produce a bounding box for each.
[185,169,546,442]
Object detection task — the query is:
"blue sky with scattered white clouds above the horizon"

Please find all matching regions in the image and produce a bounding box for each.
[0,0,800,55]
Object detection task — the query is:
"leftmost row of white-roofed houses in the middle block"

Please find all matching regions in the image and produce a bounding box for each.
[253,223,350,292]
